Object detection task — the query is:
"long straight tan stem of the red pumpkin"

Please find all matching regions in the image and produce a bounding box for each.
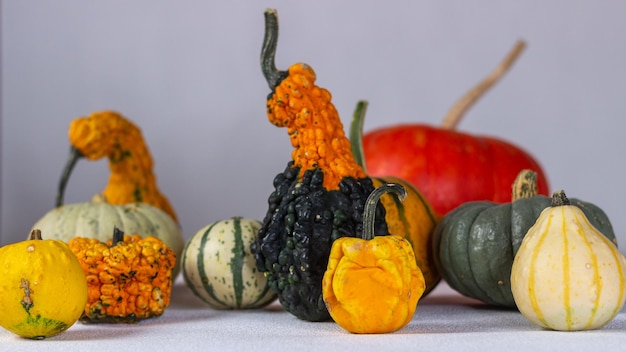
[441,40,526,130]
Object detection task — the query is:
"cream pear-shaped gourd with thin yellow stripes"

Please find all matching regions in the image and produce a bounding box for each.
[511,191,626,331]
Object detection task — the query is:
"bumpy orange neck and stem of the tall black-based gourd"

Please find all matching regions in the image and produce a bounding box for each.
[261,10,366,190]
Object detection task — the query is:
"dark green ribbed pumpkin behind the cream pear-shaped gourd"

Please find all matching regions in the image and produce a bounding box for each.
[433,170,617,308]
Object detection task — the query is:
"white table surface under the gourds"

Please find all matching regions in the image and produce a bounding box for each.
[0,276,626,352]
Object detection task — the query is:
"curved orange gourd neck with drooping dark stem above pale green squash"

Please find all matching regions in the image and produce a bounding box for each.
[56,111,177,221]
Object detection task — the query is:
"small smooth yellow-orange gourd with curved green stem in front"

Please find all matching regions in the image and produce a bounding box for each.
[322,184,426,334]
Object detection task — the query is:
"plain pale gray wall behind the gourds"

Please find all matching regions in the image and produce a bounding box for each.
[0,0,626,252]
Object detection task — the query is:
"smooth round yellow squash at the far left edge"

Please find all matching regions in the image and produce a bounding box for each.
[0,230,87,339]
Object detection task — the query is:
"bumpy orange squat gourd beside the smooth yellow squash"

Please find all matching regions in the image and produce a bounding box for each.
[69,228,176,323]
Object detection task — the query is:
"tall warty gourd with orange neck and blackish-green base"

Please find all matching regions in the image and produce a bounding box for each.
[251,10,388,321]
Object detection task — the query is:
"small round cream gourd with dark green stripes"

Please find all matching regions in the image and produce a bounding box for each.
[182,217,276,309]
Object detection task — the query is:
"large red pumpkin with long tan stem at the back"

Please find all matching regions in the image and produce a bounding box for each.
[356,41,549,215]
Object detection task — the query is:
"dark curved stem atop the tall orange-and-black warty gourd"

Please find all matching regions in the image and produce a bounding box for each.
[261,9,289,91]
